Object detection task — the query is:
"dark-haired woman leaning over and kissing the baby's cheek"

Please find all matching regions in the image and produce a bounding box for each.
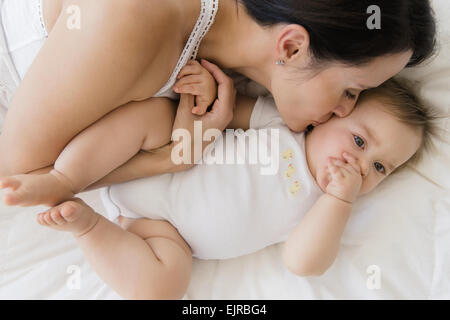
[0,0,435,182]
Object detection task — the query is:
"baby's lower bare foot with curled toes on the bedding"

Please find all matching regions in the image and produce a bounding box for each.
[36,199,100,237]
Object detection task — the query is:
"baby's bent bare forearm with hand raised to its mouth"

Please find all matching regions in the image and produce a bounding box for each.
[283,154,362,276]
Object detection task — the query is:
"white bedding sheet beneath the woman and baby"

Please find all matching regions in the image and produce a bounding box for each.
[0,0,450,299]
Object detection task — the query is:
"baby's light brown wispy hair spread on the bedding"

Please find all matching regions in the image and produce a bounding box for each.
[358,78,442,166]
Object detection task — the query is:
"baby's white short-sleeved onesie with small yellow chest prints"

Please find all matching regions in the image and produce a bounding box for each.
[102,97,322,259]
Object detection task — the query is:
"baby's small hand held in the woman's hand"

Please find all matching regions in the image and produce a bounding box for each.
[174,60,217,115]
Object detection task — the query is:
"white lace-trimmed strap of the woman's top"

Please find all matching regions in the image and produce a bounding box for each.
[155,0,219,99]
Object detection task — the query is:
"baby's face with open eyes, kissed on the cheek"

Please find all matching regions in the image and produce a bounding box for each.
[306,98,421,194]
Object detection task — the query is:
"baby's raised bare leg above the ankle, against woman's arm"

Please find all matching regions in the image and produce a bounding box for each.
[54,98,176,193]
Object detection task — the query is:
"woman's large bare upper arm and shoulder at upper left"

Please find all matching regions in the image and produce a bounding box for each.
[0,0,179,176]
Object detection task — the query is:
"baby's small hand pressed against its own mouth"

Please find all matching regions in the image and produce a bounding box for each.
[326,152,362,203]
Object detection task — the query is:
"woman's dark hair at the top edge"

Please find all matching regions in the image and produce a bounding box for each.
[236,0,436,67]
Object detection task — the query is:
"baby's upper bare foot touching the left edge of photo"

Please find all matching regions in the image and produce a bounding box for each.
[0,174,74,207]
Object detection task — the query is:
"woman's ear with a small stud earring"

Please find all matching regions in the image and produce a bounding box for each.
[276,24,309,62]
